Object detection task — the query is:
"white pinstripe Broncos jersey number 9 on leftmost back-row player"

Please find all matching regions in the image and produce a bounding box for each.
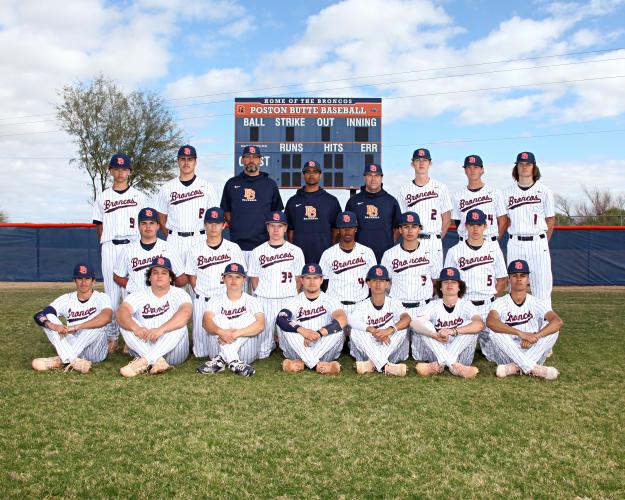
[93,186,146,243]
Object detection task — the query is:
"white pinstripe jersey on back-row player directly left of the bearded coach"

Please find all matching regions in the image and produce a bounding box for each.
[154,177,219,232]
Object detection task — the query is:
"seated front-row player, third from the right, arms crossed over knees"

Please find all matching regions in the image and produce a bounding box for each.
[348,266,410,377]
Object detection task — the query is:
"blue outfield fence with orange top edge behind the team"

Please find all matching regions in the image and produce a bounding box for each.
[0,224,625,285]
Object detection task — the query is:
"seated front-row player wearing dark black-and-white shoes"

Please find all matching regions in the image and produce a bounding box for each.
[197,262,265,377]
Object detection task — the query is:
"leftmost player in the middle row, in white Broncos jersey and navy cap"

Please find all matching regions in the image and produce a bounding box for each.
[113,207,187,293]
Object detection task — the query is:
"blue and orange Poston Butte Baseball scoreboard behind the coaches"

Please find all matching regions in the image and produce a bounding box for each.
[234,97,382,189]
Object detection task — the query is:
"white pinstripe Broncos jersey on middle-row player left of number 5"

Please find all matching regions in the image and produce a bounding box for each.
[382,243,441,302]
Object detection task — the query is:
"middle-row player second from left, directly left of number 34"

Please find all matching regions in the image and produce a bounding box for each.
[185,207,245,358]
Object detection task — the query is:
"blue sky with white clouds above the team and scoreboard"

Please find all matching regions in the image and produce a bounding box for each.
[0,0,625,222]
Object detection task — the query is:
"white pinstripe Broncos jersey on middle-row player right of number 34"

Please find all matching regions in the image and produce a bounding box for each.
[319,243,378,302]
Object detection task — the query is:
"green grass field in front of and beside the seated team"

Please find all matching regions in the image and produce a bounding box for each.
[0,289,625,499]
